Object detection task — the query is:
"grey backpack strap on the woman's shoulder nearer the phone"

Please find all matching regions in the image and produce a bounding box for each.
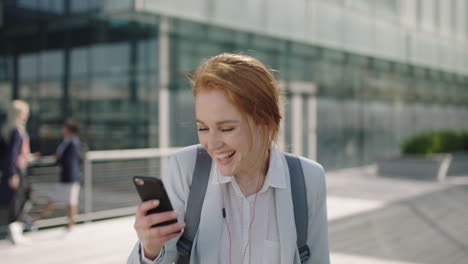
[177,145,211,264]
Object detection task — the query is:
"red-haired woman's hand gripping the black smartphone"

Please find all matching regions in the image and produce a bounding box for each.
[134,200,185,260]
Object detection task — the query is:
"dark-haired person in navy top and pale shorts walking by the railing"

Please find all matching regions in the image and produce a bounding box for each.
[36,119,81,231]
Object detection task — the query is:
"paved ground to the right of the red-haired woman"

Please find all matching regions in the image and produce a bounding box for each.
[327,166,468,264]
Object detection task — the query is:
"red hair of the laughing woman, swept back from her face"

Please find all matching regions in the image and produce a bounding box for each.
[192,53,283,163]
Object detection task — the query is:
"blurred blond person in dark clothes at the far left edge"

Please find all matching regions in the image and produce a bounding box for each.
[0,100,30,244]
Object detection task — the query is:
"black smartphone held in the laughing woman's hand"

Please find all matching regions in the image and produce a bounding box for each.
[133,176,177,227]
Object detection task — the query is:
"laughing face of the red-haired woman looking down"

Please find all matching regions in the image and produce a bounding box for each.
[195,89,261,176]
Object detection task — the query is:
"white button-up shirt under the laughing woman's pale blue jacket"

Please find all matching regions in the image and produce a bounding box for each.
[141,147,287,264]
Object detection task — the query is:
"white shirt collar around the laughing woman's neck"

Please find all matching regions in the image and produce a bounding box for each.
[211,143,286,191]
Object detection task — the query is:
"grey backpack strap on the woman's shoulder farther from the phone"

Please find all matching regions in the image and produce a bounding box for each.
[283,153,310,263]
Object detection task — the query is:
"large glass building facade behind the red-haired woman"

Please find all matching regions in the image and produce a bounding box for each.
[0,0,468,168]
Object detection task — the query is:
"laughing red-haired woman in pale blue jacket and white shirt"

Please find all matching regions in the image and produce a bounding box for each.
[128,54,329,264]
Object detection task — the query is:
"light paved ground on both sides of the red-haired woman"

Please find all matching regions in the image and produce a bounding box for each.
[0,166,468,264]
